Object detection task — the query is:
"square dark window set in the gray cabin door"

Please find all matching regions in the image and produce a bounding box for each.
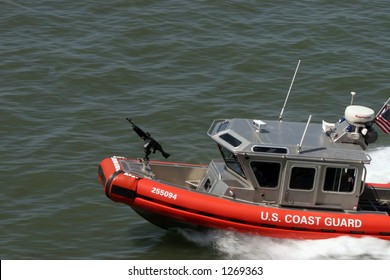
[289,166,316,190]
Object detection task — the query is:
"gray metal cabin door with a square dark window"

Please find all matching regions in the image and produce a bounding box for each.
[280,161,318,206]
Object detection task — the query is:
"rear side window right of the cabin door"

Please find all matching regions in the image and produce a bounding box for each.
[323,167,356,192]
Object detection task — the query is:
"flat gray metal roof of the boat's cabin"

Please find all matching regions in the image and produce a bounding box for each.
[208,119,370,163]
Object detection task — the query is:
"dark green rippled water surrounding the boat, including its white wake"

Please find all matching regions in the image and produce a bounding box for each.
[0,0,390,260]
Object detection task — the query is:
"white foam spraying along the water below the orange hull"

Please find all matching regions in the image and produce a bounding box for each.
[215,232,390,260]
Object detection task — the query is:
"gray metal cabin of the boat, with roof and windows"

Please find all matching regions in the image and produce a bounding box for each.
[198,113,375,211]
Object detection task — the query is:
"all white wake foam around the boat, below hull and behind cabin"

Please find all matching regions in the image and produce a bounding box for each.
[181,147,390,260]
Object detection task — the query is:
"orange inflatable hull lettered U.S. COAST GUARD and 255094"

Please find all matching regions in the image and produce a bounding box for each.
[98,158,390,240]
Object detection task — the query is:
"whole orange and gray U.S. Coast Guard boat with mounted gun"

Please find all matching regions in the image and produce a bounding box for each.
[98,74,390,240]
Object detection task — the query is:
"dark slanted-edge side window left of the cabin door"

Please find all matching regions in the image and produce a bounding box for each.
[251,161,280,188]
